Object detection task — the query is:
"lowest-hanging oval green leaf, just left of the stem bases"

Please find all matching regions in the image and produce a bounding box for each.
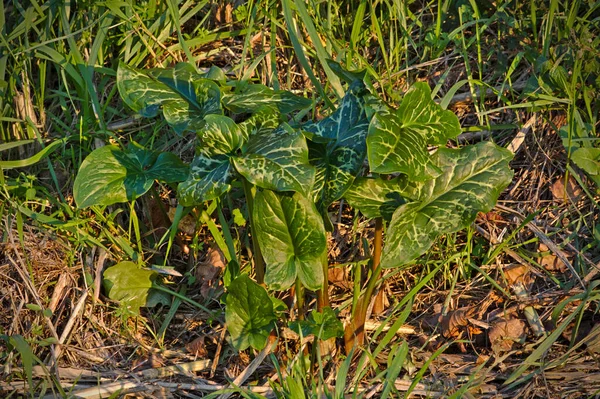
[225,274,277,351]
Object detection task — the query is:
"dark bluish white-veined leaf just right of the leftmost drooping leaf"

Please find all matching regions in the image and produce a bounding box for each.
[177,154,232,206]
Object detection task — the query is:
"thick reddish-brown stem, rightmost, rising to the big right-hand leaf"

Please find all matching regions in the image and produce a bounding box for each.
[344,218,383,354]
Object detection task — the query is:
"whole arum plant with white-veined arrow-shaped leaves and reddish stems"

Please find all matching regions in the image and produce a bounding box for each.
[74,63,512,352]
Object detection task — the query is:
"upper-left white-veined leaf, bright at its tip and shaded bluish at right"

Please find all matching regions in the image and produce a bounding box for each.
[117,63,222,134]
